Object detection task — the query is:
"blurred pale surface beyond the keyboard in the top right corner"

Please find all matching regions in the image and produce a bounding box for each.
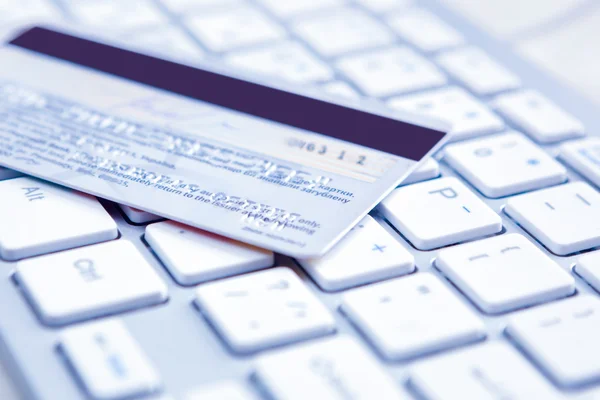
[442,0,600,108]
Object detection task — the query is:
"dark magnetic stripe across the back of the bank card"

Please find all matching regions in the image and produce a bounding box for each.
[10,27,444,160]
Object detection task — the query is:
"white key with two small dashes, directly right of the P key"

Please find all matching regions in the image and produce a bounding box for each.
[505,182,600,255]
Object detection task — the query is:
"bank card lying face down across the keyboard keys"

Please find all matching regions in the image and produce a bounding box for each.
[0,27,448,258]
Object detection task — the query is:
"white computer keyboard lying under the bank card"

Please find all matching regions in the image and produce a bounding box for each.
[0,0,600,400]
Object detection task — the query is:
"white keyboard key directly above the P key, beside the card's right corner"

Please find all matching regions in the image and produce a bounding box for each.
[444,132,567,198]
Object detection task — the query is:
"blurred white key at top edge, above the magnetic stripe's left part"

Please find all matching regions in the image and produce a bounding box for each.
[68,0,168,34]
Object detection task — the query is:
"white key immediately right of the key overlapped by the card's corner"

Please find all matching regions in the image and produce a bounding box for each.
[493,90,585,143]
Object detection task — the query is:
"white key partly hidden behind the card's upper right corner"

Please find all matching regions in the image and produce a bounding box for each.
[389,87,504,140]
